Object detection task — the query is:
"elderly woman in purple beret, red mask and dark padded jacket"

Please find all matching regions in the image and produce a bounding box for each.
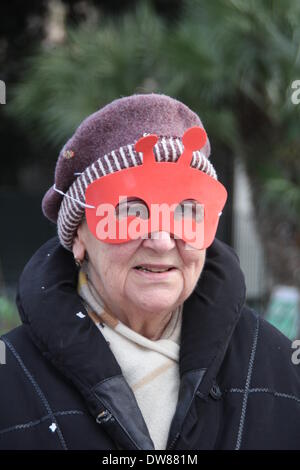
[0,94,300,450]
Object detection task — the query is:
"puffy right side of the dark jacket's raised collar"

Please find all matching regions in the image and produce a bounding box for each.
[179,239,246,395]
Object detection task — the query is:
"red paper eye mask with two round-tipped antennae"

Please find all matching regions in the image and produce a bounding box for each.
[85,127,227,249]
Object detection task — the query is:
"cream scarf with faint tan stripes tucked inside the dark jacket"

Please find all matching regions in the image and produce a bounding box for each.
[78,262,182,450]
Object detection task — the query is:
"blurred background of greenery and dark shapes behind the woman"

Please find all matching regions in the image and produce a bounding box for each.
[0,0,300,339]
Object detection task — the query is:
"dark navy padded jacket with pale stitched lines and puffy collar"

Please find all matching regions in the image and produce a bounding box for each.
[0,237,300,450]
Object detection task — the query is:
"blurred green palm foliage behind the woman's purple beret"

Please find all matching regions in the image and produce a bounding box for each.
[5,0,300,229]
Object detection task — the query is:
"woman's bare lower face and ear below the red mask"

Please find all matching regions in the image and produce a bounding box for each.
[73,220,206,314]
